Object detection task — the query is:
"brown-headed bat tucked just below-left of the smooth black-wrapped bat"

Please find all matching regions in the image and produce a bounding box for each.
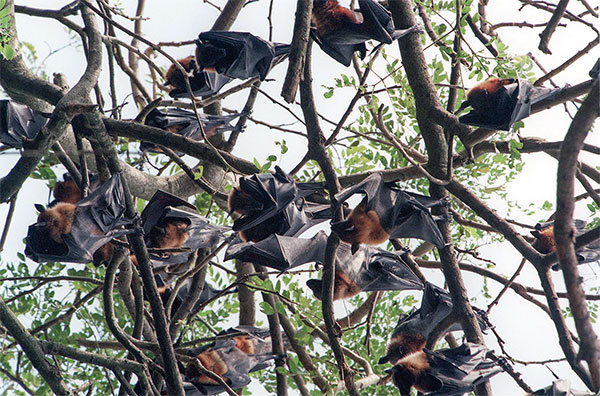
[165,55,232,98]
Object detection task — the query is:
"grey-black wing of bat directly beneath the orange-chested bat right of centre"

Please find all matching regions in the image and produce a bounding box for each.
[356,247,423,291]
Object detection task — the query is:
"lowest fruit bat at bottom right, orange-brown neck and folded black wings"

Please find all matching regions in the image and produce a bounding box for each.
[391,343,502,396]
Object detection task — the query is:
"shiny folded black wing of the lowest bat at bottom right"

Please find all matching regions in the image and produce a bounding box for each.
[424,343,502,396]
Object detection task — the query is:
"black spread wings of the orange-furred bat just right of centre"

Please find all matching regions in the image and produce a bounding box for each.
[332,173,448,247]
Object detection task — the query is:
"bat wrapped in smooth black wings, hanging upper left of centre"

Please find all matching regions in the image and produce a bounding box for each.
[196,31,290,81]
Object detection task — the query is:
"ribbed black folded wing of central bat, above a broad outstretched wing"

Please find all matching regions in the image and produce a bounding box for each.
[233,166,298,231]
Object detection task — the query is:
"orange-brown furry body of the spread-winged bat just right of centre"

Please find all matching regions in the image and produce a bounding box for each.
[336,198,390,246]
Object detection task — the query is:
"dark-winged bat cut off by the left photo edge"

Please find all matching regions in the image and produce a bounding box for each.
[0,99,51,149]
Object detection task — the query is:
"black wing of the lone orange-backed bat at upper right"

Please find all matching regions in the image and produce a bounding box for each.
[459,78,565,131]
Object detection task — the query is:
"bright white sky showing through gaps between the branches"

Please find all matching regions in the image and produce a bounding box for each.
[0,0,600,395]
